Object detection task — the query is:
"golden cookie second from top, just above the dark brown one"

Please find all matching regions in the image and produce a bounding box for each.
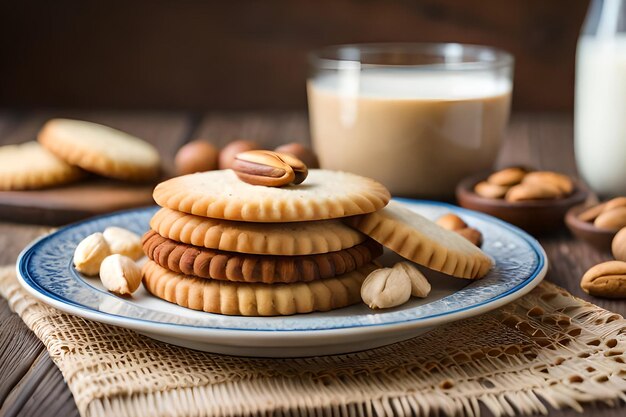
[150,208,366,255]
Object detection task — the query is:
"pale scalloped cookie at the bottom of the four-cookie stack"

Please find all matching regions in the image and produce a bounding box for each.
[143,261,378,316]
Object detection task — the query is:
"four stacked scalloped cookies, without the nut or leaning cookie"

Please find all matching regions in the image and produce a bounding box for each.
[143,170,390,316]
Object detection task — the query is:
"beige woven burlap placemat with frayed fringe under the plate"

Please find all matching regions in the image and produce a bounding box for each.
[0,266,626,416]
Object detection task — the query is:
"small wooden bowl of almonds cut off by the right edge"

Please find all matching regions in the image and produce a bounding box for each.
[565,197,626,252]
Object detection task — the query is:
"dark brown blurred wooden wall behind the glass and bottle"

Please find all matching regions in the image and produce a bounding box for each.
[0,0,588,111]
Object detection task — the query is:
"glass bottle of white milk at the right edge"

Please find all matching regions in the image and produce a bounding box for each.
[574,0,626,197]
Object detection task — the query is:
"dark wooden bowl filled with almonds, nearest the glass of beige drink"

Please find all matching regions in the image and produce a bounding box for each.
[456,169,589,235]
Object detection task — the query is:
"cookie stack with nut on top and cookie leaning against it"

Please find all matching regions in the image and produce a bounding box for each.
[143,151,492,316]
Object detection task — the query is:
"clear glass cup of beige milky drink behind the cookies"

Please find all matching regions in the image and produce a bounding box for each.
[307,43,513,198]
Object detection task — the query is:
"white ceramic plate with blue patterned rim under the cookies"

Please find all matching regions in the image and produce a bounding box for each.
[17,200,547,357]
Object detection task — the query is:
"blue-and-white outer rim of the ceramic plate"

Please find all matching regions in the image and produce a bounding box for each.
[17,198,547,337]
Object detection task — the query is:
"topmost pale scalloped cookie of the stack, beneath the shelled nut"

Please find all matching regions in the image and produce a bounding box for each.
[153,169,390,223]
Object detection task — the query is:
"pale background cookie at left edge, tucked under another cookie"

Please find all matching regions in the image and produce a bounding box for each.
[0,141,84,191]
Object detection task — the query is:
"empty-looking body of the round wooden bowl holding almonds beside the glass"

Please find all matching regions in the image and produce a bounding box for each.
[456,174,589,235]
